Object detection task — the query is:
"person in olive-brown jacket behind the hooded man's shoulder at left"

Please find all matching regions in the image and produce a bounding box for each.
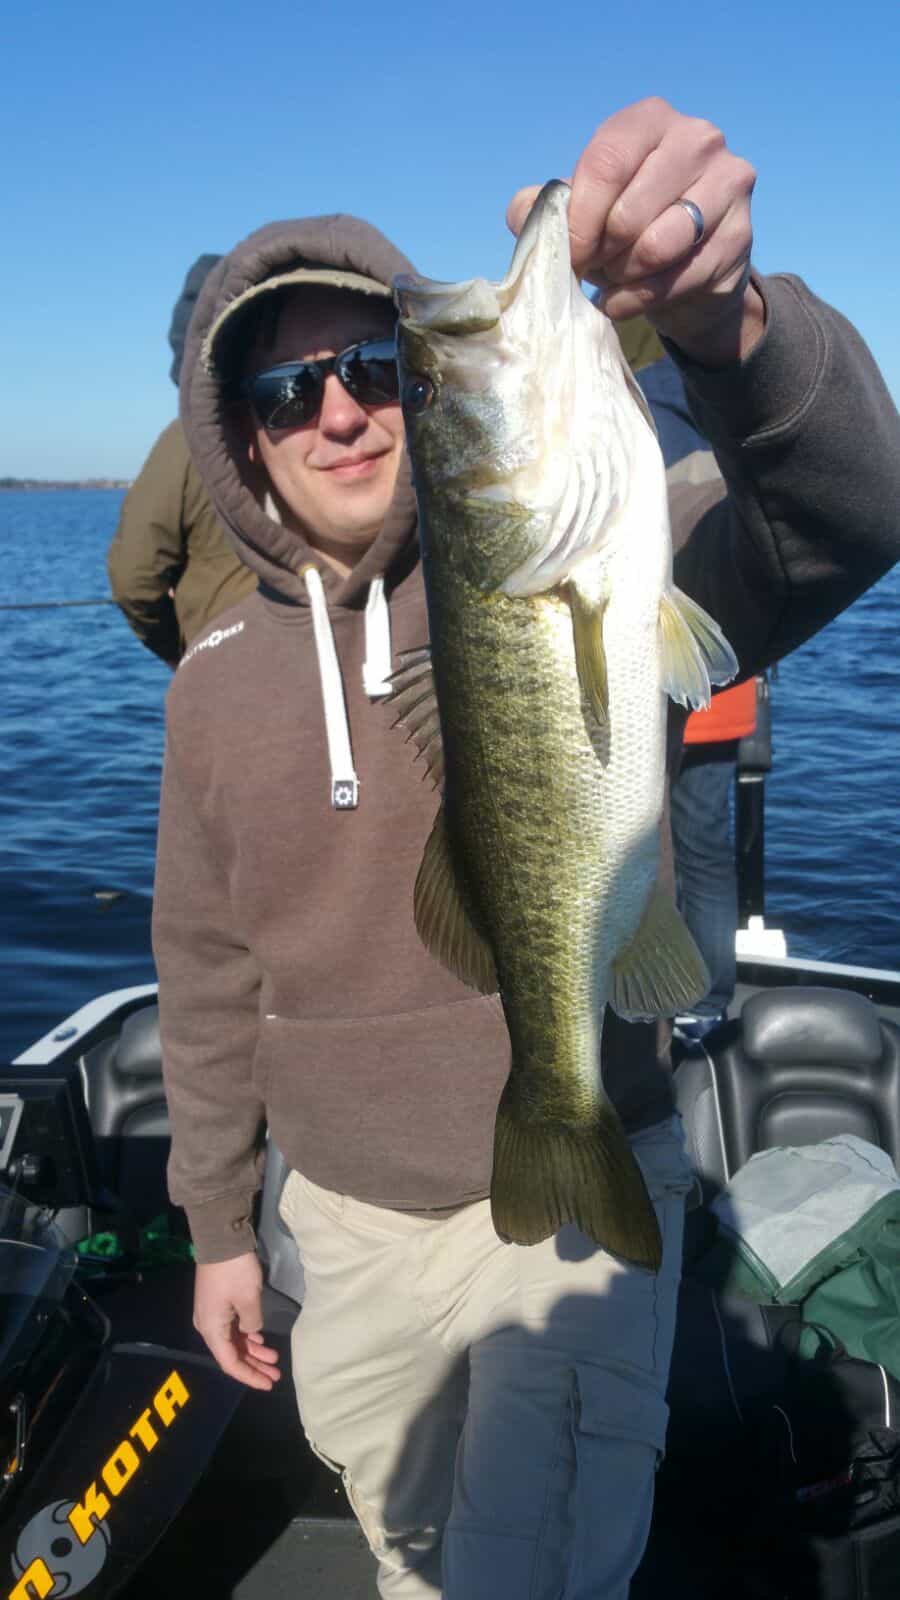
[107,256,256,669]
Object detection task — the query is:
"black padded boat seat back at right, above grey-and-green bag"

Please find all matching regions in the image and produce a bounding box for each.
[674,987,900,1195]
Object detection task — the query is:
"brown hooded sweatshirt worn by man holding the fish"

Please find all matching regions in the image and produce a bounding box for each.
[154,218,900,1261]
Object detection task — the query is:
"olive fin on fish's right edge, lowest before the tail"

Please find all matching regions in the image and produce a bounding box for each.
[609,885,709,1022]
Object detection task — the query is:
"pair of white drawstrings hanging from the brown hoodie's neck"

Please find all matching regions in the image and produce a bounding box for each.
[303,566,391,811]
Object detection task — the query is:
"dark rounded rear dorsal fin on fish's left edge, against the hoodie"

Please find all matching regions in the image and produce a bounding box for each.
[413,806,498,995]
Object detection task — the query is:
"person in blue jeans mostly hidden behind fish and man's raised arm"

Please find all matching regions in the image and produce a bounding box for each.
[618,317,756,1038]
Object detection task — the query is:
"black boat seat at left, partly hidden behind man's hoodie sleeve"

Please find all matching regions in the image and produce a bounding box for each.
[83,1005,170,1222]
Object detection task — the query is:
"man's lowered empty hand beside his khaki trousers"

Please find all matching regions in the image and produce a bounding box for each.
[194,1253,280,1389]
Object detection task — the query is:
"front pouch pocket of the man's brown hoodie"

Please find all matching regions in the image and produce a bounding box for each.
[255,995,509,1210]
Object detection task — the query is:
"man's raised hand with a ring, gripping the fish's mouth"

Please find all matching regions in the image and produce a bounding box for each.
[506,99,765,366]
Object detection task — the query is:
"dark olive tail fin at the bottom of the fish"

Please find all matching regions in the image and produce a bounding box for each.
[490,1078,663,1272]
